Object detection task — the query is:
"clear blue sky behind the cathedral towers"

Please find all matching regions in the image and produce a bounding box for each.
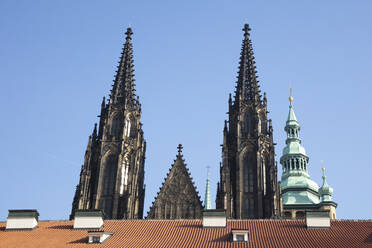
[0,0,372,220]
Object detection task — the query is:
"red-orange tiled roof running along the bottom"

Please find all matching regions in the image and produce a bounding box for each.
[0,220,372,248]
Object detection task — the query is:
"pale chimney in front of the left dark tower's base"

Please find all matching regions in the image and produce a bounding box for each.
[74,209,103,229]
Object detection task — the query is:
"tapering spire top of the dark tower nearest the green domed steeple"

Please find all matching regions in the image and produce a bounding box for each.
[235,24,261,106]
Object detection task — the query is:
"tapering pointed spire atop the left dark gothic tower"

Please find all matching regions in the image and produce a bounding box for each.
[110,28,135,104]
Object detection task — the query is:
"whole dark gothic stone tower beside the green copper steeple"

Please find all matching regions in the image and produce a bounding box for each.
[216,24,281,219]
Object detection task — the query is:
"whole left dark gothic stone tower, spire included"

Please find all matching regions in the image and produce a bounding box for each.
[70,28,146,219]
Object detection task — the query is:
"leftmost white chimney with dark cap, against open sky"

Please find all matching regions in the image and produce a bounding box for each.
[5,209,39,231]
